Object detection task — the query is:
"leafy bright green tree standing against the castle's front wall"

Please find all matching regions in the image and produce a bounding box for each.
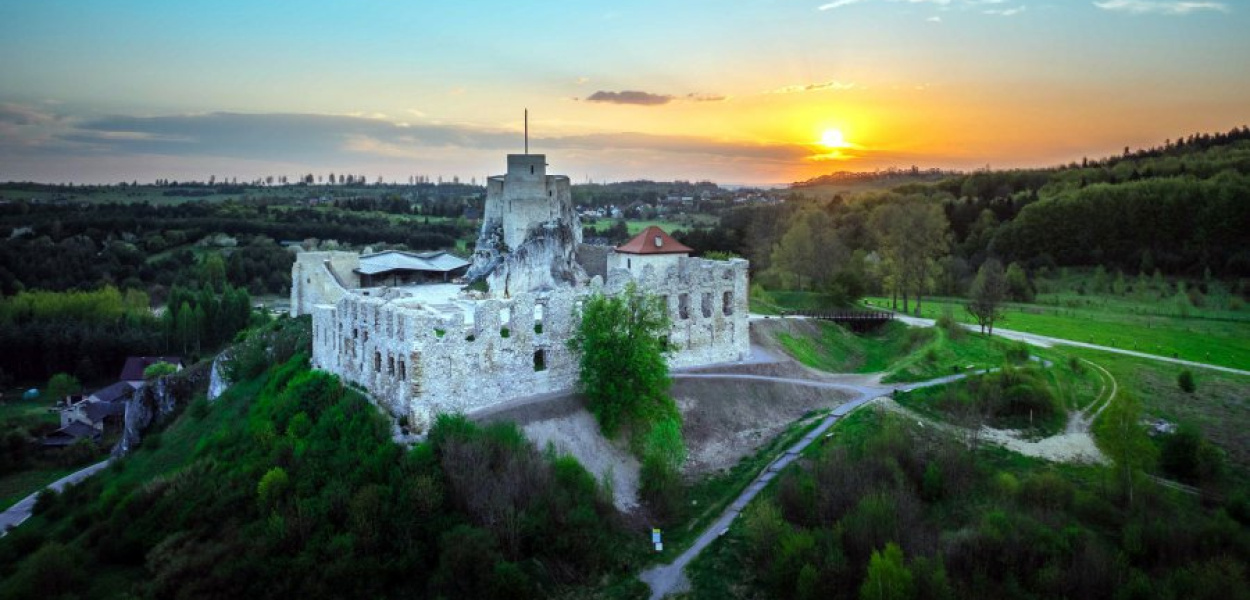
[569,284,681,436]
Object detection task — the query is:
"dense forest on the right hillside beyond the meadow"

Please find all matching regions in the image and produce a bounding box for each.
[674,128,1250,310]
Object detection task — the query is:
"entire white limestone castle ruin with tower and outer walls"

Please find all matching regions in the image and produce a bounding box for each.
[291,154,750,433]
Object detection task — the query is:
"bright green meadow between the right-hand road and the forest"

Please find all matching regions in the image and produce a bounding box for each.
[865,298,1250,370]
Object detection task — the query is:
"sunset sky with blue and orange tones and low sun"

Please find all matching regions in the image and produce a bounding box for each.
[0,0,1250,184]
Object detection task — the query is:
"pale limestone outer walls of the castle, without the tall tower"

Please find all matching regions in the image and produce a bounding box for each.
[306,258,750,433]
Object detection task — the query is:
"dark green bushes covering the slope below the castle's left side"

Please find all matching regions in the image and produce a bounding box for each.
[0,345,638,599]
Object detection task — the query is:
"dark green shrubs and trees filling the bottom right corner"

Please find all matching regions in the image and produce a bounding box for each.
[725,413,1250,599]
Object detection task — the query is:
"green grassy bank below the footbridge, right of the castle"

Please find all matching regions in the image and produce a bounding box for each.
[778,323,1020,381]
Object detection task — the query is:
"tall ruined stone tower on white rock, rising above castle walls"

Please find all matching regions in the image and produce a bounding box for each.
[468,154,586,298]
